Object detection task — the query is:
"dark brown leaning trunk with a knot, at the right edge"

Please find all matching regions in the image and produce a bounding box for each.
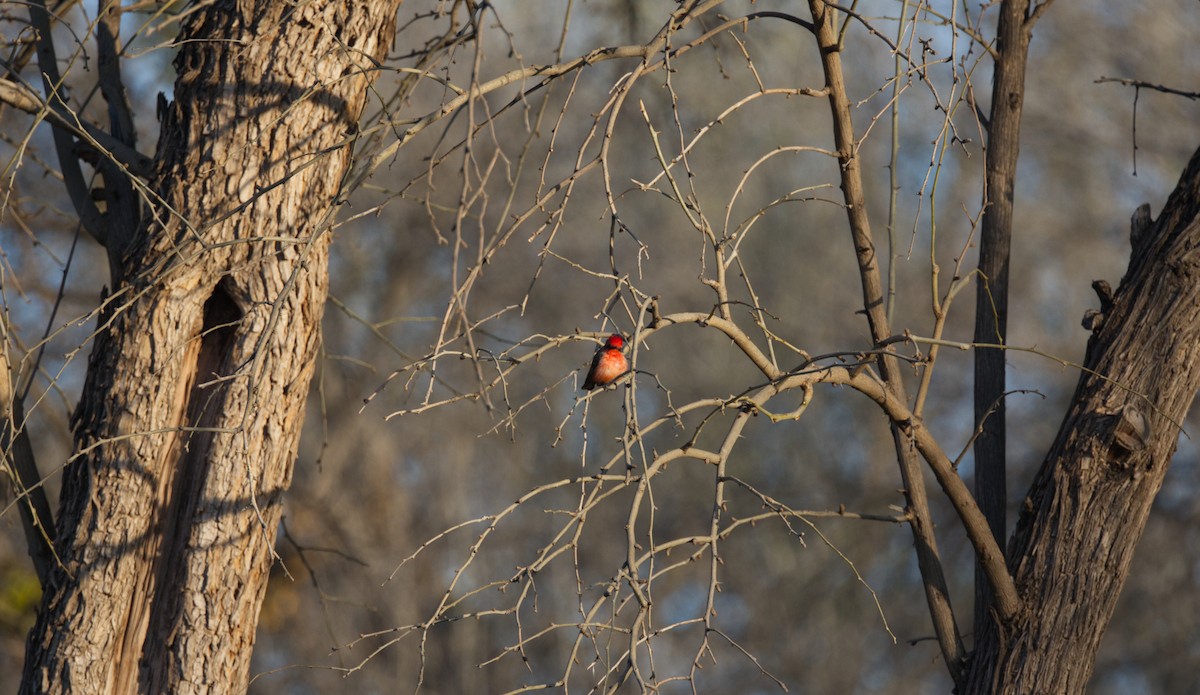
[967,145,1200,695]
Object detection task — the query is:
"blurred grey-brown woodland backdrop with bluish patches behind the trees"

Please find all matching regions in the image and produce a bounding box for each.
[0,1,1200,693]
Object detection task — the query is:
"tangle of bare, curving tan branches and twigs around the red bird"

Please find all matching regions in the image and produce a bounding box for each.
[324,1,1036,691]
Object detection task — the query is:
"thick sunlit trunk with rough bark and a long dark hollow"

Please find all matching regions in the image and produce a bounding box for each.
[22,0,400,694]
